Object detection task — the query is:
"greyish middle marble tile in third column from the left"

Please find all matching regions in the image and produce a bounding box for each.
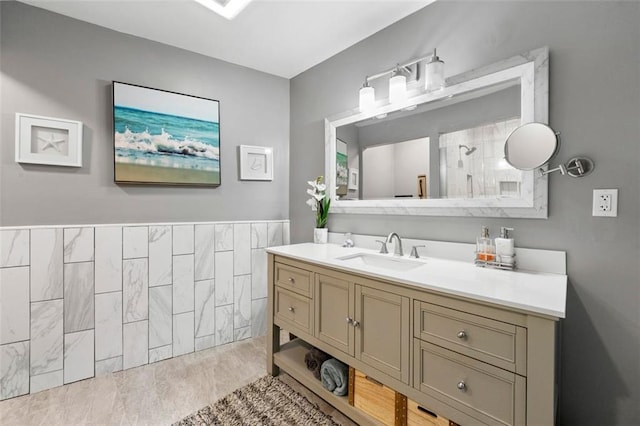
[64,262,95,333]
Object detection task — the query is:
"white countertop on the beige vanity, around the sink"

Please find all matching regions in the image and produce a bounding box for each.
[267,243,567,318]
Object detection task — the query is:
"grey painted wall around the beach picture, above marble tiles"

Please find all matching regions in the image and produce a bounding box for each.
[0,2,289,226]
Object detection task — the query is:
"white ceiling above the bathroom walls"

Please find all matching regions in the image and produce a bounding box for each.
[22,0,435,78]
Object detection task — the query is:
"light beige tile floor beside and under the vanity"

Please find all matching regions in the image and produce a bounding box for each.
[0,337,354,426]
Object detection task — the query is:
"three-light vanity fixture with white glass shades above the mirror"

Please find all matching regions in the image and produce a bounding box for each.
[356,49,445,118]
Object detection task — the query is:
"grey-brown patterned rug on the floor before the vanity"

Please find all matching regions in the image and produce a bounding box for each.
[174,376,339,426]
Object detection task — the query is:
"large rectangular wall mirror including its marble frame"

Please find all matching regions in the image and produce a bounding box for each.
[325,47,549,218]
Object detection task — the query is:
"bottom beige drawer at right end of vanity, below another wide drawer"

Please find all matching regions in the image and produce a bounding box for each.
[414,339,526,425]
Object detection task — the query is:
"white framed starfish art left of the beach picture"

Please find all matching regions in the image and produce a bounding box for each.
[15,113,82,167]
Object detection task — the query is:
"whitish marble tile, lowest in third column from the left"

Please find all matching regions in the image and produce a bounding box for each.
[64,330,95,384]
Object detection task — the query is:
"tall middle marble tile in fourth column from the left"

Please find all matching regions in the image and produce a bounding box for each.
[95,291,122,360]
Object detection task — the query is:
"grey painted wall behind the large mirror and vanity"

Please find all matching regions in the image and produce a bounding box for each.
[290,1,640,425]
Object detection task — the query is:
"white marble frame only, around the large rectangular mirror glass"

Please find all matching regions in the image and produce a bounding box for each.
[325,47,549,219]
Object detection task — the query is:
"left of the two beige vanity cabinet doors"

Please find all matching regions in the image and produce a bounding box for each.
[314,274,355,356]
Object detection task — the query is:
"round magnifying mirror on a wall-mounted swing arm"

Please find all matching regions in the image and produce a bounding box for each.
[504,123,559,170]
